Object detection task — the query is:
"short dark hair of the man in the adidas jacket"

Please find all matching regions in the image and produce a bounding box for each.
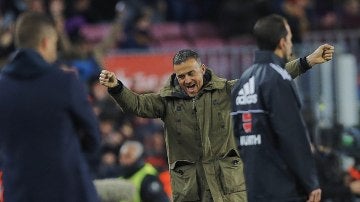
[253,14,288,51]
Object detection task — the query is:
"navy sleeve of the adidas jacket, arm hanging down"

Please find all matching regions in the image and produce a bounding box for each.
[263,77,319,193]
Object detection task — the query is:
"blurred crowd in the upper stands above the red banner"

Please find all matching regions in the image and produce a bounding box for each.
[0,0,360,61]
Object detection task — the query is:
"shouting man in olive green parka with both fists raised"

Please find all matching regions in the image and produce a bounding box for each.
[99,46,332,202]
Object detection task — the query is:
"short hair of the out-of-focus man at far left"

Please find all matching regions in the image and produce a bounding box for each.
[15,12,55,48]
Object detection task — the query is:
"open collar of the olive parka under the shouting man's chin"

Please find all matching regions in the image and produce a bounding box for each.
[160,69,226,99]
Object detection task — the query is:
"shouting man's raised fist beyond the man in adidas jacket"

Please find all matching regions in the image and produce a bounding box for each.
[306,44,334,66]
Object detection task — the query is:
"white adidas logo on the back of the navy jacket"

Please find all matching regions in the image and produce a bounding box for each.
[235,76,257,105]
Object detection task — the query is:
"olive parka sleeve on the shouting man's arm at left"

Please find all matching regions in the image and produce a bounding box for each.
[109,86,165,118]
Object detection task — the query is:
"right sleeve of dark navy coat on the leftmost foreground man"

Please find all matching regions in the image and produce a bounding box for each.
[69,73,100,153]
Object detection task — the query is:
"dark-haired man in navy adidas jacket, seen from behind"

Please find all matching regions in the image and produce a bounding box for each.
[232,15,333,202]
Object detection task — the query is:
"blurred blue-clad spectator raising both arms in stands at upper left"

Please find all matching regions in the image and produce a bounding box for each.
[49,0,123,84]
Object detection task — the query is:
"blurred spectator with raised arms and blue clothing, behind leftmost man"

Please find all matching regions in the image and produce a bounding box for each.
[49,0,125,86]
